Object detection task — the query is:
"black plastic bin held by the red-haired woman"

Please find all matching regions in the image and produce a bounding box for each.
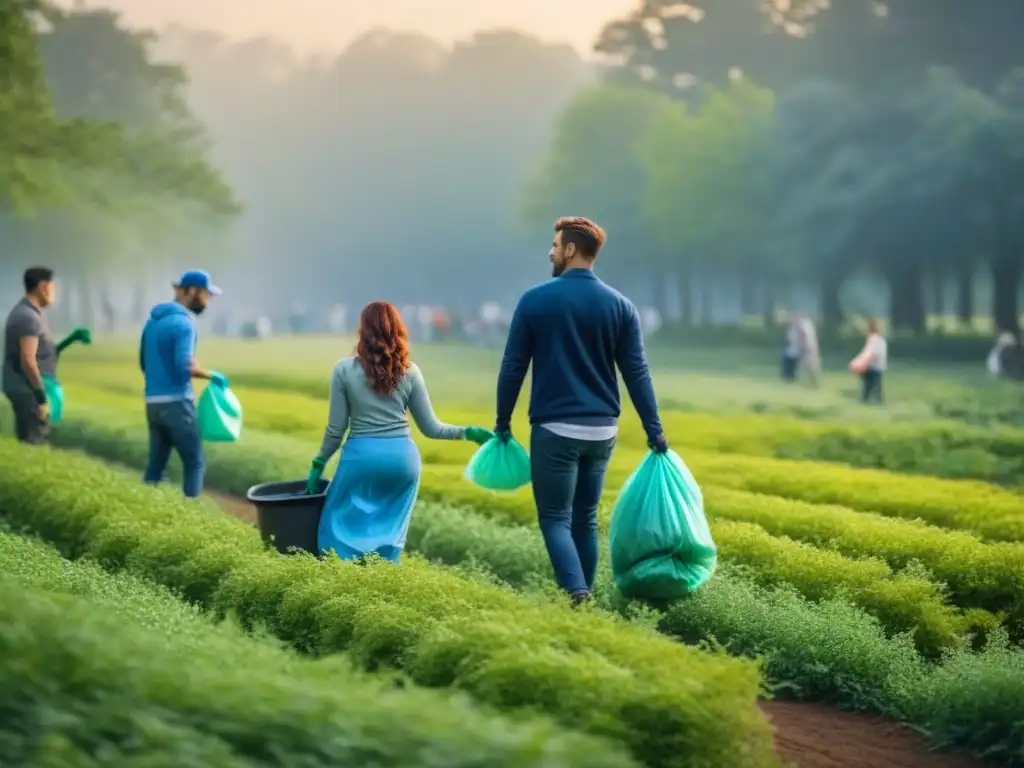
[246,480,328,555]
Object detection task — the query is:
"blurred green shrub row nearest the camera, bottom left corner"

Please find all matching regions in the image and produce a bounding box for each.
[0,535,636,768]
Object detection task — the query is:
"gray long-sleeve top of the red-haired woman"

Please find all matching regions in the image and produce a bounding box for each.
[317,356,466,462]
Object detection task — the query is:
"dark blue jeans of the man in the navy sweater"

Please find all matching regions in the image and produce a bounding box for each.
[529,426,615,595]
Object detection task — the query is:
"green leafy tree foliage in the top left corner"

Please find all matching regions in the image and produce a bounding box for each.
[0,2,241,273]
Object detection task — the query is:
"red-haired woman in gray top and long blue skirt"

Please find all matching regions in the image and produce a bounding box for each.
[306,301,494,562]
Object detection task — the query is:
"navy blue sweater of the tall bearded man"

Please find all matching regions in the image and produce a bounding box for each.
[496,269,662,439]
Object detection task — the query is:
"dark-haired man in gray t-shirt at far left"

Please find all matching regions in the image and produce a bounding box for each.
[3,266,92,445]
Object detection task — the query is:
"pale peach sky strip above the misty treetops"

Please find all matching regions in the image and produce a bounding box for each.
[88,0,636,52]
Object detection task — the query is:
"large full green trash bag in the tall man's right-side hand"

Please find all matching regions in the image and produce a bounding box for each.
[610,451,718,600]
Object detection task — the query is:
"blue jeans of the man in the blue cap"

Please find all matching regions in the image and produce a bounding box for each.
[142,400,206,499]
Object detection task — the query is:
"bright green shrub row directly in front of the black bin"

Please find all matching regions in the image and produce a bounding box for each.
[0,441,777,767]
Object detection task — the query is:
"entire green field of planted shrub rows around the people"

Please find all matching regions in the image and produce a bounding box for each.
[0,338,1024,768]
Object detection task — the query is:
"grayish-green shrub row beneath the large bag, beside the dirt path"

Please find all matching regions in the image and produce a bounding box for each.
[409,504,1024,766]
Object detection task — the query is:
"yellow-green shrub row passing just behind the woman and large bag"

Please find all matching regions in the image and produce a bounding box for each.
[36,411,999,656]
